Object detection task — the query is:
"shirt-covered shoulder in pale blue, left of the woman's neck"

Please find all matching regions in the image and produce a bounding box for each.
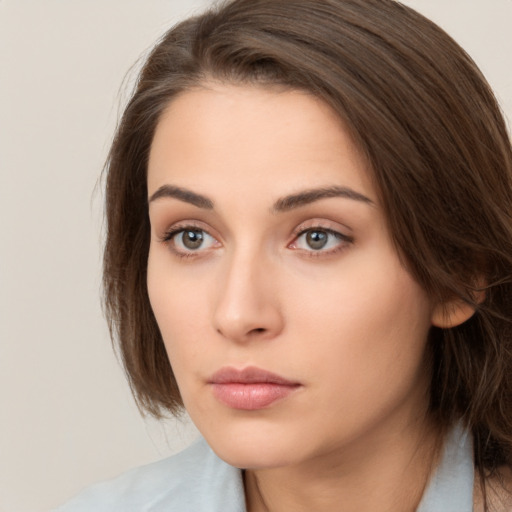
[54,440,244,512]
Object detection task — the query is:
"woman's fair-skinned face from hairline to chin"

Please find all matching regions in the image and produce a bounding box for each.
[148,84,432,468]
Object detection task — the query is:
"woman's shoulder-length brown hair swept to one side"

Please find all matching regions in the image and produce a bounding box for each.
[104,0,512,496]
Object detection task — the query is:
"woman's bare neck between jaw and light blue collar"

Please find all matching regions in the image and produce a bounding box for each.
[245,414,441,512]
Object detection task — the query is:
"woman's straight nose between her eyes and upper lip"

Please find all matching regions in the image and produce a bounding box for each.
[213,249,284,343]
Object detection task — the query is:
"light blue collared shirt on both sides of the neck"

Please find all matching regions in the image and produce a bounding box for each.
[55,426,474,512]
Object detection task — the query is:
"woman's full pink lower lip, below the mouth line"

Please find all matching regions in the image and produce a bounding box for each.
[212,382,299,411]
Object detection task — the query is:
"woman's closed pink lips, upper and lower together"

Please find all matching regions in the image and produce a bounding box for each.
[208,366,301,411]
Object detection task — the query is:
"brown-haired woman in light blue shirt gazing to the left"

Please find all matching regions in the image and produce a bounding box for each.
[55,0,512,512]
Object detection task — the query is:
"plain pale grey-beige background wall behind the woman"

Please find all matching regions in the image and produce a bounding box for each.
[0,0,512,512]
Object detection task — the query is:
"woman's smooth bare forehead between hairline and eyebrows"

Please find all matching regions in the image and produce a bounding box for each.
[148,84,375,204]
